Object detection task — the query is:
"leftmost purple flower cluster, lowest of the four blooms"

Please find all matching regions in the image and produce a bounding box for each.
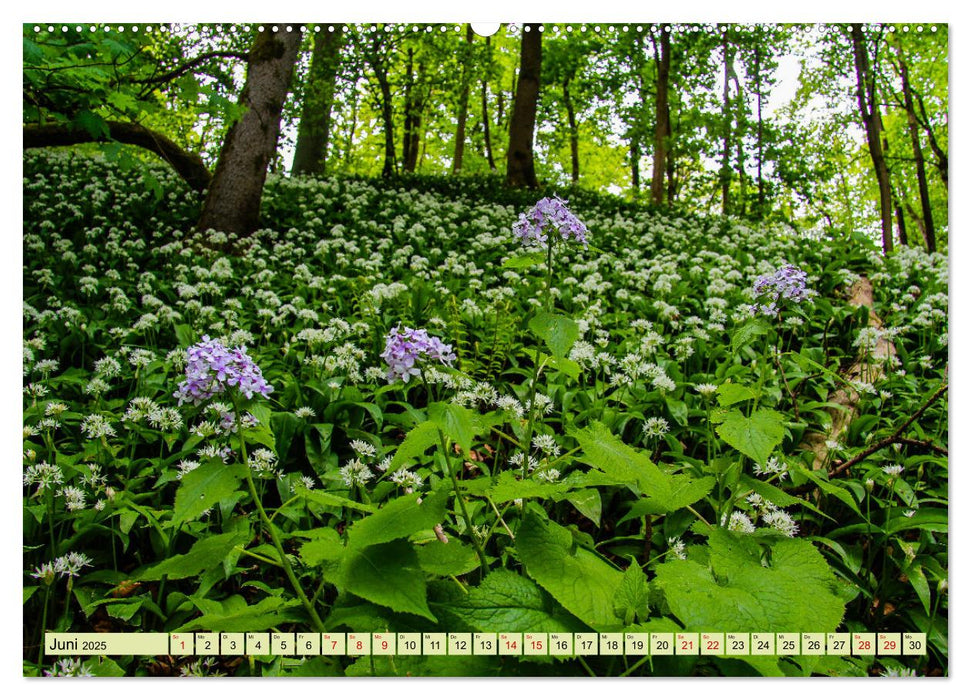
[173,335,273,406]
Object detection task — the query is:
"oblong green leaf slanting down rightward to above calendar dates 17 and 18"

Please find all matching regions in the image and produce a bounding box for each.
[516,508,624,631]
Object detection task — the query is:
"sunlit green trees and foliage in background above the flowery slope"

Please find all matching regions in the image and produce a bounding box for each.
[23,24,948,248]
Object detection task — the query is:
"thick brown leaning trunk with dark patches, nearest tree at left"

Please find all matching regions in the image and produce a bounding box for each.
[198,25,300,235]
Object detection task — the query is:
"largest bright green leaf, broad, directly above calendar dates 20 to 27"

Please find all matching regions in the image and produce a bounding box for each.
[653,528,843,632]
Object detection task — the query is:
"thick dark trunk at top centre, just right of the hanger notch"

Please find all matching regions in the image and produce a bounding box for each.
[506,24,543,189]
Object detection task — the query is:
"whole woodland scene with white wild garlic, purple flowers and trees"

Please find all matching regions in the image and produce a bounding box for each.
[22,23,949,677]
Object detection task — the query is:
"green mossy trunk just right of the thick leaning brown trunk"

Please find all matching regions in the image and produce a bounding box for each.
[291,24,344,175]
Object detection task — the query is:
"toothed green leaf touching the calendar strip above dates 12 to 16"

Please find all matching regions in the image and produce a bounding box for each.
[431,569,586,632]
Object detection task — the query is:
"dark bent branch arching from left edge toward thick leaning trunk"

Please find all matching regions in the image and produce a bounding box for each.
[24,121,212,192]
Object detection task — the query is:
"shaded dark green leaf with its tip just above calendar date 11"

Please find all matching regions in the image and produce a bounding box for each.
[338,540,437,622]
